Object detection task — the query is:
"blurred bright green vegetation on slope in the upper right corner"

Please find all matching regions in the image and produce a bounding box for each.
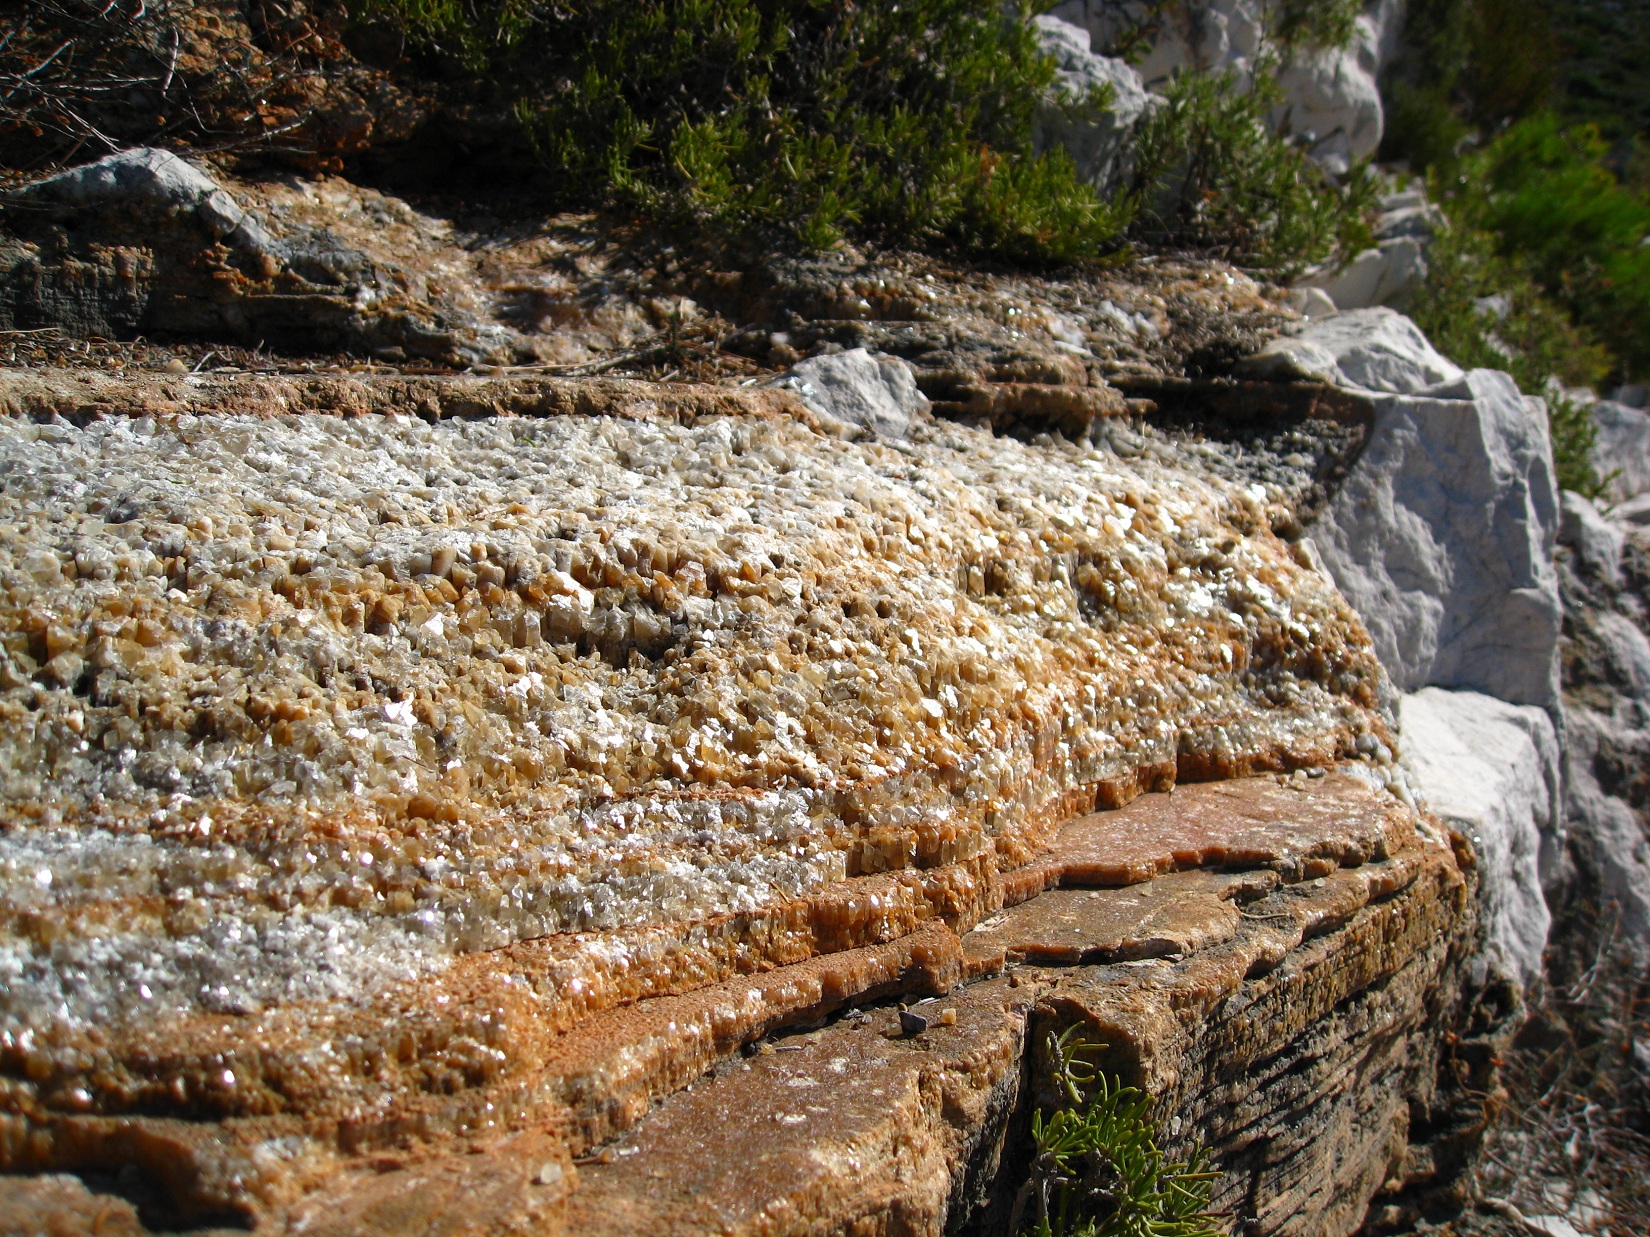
[1381,0,1650,493]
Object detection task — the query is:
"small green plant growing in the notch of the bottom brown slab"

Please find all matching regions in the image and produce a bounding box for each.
[1010,1028,1226,1237]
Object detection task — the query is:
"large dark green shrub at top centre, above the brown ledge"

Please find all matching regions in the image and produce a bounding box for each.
[356,0,1127,261]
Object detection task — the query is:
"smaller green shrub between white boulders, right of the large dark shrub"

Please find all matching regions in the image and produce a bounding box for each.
[1129,64,1374,279]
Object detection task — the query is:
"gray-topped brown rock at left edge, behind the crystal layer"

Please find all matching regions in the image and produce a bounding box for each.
[0,147,485,363]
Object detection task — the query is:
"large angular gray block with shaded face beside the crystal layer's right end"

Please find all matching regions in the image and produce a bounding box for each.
[1312,367,1559,708]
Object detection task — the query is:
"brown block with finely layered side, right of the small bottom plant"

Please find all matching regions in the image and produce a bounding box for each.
[1033,846,1482,1237]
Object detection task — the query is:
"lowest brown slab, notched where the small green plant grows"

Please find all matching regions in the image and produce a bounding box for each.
[551,834,1469,1235]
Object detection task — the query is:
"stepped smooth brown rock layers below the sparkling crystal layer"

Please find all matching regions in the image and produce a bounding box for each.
[5,774,1485,1234]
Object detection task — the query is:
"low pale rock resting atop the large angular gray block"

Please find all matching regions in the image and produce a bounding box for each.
[1244,307,1462,394]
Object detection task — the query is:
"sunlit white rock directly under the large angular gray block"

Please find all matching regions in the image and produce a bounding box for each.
[1399,688,1564,986]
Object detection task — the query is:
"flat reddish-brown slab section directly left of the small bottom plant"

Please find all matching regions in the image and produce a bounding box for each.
[568,980,1038,1237]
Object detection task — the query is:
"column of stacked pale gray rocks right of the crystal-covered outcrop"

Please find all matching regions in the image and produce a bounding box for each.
[1246,308,1570,1009]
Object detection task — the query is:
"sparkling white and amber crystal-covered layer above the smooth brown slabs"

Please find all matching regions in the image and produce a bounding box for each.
[0,387,1391,1179]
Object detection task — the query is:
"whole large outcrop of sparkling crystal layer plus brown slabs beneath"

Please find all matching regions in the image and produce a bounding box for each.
[0,367,1498,1234]
